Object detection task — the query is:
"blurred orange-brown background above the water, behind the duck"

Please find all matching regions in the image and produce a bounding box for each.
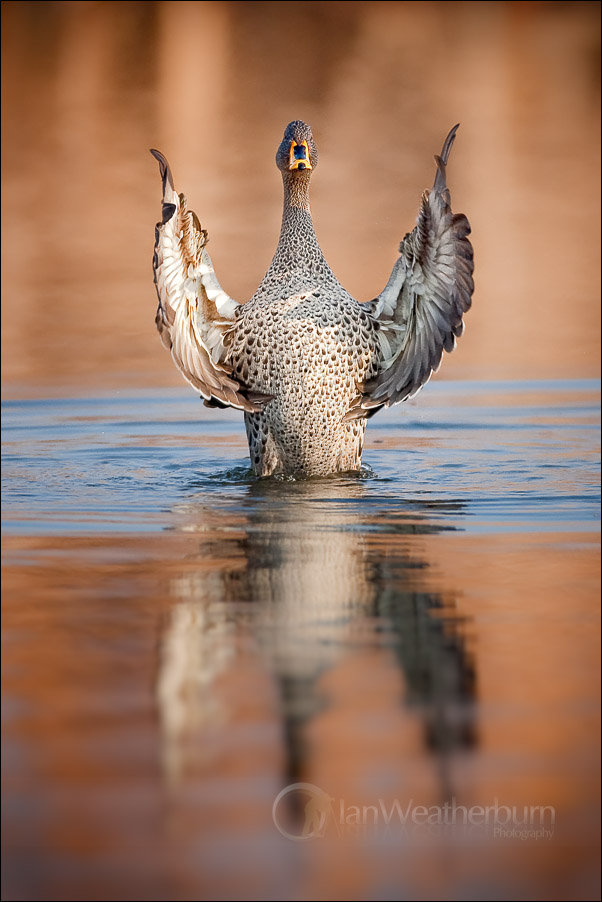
[2,0,600,397]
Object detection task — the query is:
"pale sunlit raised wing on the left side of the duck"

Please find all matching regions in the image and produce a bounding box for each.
[151,150,270,412]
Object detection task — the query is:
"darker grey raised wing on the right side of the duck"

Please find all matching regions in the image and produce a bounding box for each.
[346,125,474,419]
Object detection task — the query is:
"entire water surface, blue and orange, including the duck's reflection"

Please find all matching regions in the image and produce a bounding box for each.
[2,381,599,899]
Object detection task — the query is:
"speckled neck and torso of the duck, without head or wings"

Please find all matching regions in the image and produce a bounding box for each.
[230,190,378,476]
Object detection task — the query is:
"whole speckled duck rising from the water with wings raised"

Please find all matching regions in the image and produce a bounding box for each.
[151,120,474,478]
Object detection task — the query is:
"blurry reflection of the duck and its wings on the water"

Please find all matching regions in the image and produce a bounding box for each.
[157,477,475,798]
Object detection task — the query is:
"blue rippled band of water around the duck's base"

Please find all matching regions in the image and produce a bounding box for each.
[3,380,599,533]
